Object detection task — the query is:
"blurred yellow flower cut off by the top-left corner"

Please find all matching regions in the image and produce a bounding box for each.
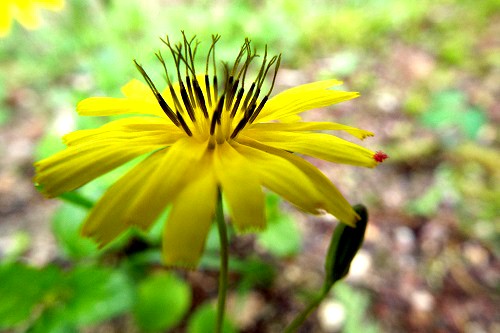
[0,0,64,37]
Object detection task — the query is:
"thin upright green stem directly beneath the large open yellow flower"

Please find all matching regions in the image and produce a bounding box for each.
[215,189,228,333]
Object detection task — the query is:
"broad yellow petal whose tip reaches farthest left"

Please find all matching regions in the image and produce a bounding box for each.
[34,142,162,197]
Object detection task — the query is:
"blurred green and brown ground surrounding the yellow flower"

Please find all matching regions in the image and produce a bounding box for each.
[0,0,500,333]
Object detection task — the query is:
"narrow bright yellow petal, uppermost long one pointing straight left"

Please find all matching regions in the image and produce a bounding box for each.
[76,97,168,119]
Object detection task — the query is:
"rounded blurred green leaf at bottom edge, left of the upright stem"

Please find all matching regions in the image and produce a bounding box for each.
[133,273,191,332]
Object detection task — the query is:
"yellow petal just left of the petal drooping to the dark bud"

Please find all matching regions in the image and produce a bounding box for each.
[235,140,325,214]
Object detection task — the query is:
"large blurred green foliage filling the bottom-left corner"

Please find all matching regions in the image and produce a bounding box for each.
[0,263,132,333]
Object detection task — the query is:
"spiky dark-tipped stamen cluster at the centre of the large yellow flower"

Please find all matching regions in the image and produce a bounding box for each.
[134,33,281,147]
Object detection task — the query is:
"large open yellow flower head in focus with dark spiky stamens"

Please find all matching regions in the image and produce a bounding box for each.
[35,36,383,267]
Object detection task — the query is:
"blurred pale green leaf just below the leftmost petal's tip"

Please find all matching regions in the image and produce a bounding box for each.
[52,203,98,259]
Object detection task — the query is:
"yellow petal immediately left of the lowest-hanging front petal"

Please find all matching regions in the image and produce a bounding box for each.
[127,137,210,227]
